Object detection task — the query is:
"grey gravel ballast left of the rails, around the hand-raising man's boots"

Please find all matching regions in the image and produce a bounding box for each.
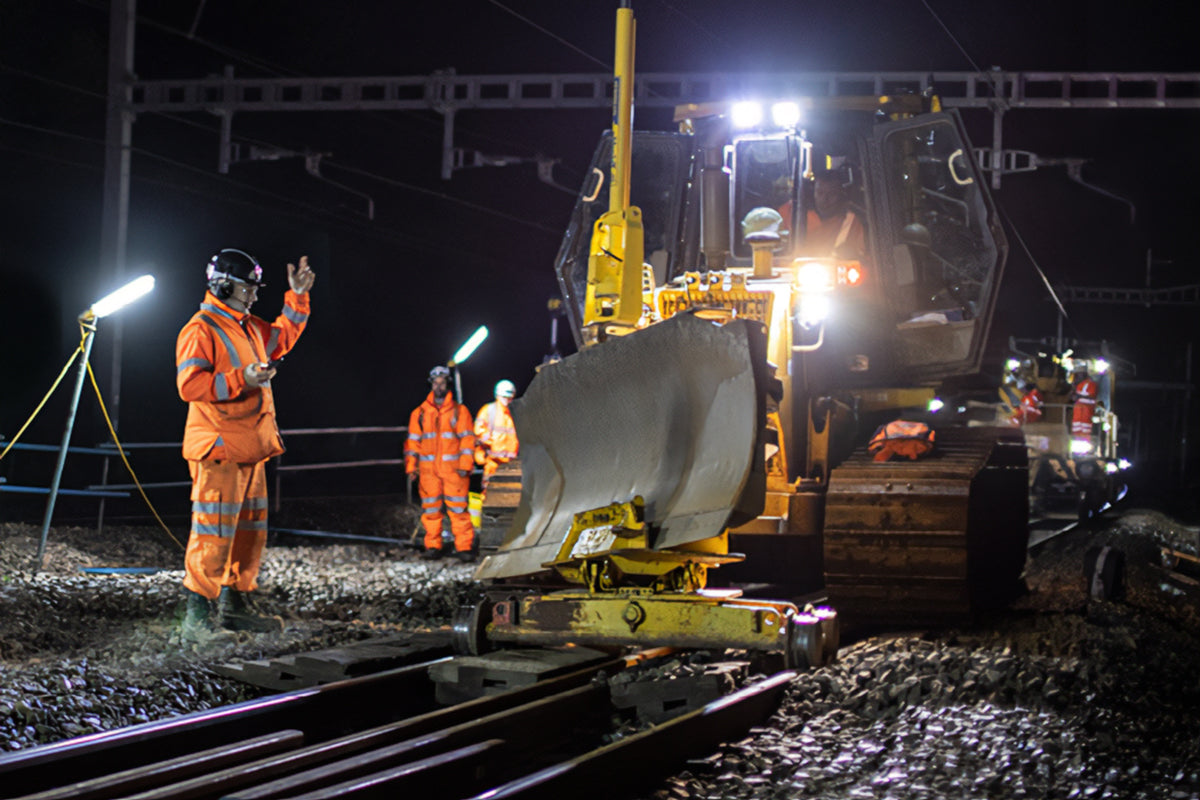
[0,523,475,750]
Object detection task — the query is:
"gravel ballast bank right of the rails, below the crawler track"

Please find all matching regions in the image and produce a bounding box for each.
[652,513,1200,800]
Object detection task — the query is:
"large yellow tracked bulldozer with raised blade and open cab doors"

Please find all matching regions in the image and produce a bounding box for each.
[456,8,1027,666]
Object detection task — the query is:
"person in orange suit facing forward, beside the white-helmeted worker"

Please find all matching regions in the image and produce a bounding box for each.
[404,367,475,563]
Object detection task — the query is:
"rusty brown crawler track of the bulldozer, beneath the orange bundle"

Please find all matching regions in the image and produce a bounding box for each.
[824,428,1028,624]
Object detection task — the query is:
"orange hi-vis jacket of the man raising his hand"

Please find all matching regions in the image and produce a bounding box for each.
[175,290,310,464]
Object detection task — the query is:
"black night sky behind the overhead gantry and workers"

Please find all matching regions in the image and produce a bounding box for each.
[0,0,1200,515]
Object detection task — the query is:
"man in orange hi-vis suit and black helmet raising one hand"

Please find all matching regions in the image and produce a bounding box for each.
[175,249,316,642]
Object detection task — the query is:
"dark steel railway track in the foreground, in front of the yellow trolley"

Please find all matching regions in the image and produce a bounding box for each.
[0,652,793,800]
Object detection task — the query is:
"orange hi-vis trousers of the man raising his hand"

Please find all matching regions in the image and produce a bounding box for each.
[184,461,266,600]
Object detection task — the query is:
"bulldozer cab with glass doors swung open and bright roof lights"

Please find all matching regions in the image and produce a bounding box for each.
[556,113,1007,390]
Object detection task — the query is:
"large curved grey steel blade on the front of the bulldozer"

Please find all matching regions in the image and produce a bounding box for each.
[475,314,769,579]
